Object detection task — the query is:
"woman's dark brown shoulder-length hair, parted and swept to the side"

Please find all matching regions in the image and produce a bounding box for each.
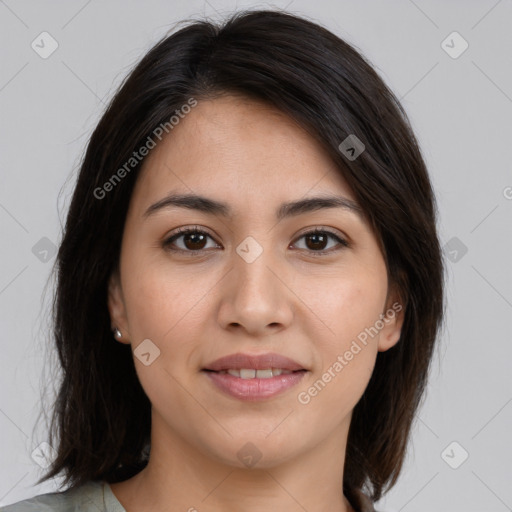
[38,7,444,501]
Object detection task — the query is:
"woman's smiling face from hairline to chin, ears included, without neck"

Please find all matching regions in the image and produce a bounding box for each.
[108,96,402,467]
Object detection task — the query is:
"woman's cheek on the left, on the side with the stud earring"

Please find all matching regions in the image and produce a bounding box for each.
[121,259,219,382]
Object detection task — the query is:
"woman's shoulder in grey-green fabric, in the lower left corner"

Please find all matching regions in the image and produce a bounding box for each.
[0,480,107,512]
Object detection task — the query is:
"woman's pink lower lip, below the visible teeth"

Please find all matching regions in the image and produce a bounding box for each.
[203,371,306,400]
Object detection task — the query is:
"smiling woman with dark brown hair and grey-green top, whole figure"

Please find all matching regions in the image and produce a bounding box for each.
[5,11,443,512]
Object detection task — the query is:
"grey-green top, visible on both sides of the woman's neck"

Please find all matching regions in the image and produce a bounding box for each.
[0,480,376,512]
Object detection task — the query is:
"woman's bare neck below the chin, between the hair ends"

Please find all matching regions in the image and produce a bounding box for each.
[111,408,353,512]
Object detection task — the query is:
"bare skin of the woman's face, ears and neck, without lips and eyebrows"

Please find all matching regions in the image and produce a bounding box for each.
[108,95,403,512]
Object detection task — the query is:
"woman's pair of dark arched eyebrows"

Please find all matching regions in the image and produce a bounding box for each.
[143,192,364,220]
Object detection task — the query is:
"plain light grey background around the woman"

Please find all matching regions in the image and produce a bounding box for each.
[0,0,512,512]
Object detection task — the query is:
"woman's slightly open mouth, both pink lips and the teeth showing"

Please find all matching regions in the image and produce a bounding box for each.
[202,353,308,401]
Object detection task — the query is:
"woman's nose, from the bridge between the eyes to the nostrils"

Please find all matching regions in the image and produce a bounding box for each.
[218,237,294,336]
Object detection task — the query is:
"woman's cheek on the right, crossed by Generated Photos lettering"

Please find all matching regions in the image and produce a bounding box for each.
[298,265,387,402]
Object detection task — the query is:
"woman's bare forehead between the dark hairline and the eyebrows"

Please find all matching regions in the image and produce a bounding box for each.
[132,95,354,216]
